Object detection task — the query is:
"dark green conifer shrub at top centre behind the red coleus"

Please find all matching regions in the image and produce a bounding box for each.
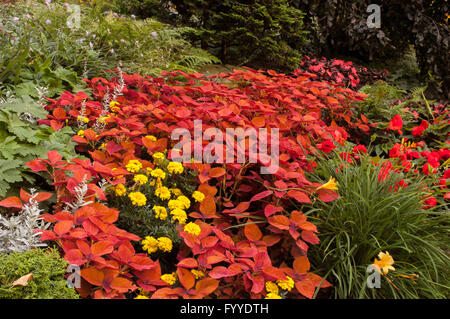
[153,0,305,70]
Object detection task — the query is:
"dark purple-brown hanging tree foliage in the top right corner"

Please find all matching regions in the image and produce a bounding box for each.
[292,0,450,100]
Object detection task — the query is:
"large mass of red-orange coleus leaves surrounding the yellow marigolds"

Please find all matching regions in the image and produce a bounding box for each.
[31,70,367,298]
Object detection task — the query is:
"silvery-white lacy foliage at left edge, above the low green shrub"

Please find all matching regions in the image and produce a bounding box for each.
[0,189,50,253]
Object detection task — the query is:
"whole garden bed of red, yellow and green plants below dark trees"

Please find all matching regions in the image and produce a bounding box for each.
[0,1,450,299]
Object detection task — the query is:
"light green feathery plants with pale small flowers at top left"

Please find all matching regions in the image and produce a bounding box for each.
[0,0,219,98]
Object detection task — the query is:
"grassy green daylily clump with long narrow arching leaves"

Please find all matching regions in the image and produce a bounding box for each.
[308,156,450,298]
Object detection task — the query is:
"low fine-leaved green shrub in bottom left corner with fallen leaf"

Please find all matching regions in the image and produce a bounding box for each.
[0,249,78,299]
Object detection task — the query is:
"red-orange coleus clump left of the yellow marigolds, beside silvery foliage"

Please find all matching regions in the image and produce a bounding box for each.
[18,151,171,298]
